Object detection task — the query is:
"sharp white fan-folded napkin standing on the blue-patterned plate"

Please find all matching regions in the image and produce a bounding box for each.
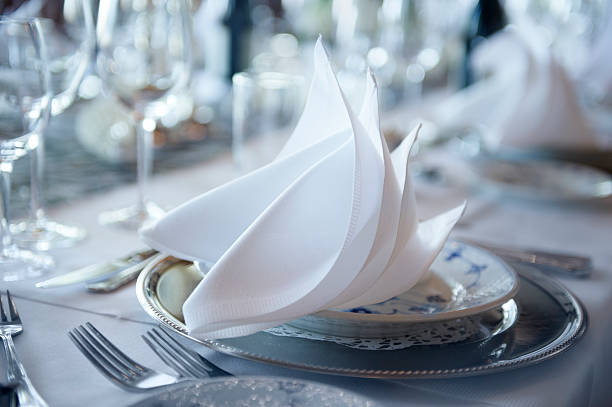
[141,40,464,338]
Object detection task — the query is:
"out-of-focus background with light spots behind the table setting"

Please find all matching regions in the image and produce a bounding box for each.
[0,0,612,215]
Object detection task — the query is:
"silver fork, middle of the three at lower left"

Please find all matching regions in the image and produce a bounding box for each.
[68,322,196,392]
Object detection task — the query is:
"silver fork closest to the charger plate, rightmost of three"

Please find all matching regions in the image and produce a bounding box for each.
[142,328,233,378]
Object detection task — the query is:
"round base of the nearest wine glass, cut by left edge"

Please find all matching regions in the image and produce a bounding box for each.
[0,247,55,281]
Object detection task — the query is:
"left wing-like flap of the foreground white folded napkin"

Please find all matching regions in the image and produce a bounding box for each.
[141,134,346,263]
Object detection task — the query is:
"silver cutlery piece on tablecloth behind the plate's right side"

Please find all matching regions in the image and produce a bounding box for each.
[461,239,593,278]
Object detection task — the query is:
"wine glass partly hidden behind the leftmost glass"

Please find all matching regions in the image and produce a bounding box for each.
[11,0,95,250]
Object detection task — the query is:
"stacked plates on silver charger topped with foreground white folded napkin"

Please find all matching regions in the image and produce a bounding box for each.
[125,40,586,378]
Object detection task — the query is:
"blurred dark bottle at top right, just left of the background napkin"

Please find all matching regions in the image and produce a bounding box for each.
[462,0,508,87]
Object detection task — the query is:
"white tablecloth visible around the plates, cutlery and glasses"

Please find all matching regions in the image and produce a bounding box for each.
[2,107,612,407]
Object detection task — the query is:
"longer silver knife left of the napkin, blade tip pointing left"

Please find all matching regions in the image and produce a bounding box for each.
[36,249,157,288]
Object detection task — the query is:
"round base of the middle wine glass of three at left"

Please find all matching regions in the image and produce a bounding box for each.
[11,219,87,250]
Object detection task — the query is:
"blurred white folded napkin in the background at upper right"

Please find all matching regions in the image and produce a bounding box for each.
[433,23,597,154]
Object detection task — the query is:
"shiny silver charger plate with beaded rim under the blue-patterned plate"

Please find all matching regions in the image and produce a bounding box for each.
[136,256,587,378]
